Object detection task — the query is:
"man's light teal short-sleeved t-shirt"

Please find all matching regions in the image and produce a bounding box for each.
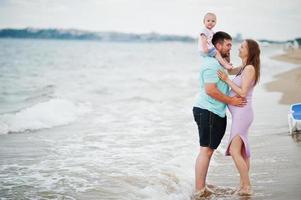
[195,56,229,117]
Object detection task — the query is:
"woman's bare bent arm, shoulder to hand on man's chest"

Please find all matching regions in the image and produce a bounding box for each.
[218,65,255,97]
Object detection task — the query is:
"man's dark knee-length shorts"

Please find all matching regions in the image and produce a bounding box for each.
[193,107,227,149]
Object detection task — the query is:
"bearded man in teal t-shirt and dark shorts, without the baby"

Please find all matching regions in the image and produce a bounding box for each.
[193,31,246,198]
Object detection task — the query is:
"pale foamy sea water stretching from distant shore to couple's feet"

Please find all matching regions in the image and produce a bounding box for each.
[0,39,300,199]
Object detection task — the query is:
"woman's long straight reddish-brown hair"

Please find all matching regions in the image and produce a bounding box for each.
[245,39,260,85]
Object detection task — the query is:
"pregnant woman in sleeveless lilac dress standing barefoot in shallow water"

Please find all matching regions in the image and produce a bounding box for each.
[218,39,260,196]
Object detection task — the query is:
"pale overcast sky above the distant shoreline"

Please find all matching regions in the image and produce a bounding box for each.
[0,0,301,40]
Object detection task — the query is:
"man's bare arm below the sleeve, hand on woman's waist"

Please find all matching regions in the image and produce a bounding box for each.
[205,83,247,107]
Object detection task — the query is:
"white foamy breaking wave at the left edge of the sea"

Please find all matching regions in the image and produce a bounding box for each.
[0,98,91,134]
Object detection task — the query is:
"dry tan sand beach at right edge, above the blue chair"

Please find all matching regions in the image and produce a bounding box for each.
[266,49,301,104]
